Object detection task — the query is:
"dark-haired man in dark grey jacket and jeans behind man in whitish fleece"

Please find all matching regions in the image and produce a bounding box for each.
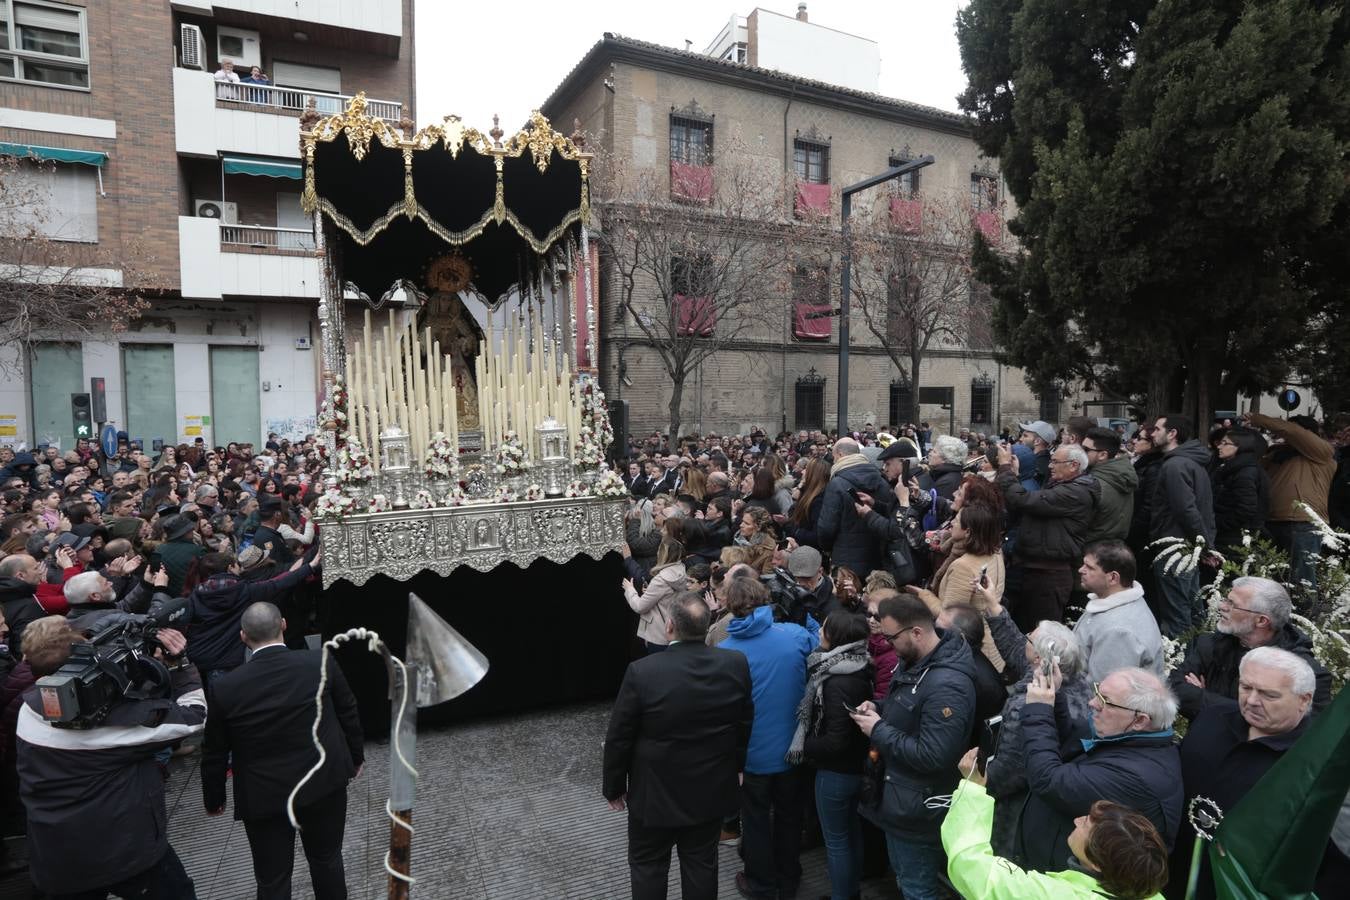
[1149,413,1215,638]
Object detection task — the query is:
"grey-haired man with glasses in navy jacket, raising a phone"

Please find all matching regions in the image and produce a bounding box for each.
[1015,665,1184,872]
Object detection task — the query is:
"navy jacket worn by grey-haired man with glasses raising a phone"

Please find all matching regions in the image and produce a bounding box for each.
[1017,703,1185,872]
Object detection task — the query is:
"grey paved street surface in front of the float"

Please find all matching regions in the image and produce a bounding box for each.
[0,703,899,900]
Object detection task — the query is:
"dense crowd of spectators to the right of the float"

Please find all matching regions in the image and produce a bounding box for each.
[603,413,1350,900]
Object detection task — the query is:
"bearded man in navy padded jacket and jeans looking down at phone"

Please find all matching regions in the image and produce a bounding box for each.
[853,594,975,900]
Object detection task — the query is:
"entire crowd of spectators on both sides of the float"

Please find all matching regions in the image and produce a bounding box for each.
[0,413,1350,900]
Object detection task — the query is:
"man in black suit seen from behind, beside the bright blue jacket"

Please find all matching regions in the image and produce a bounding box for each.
[603,592,755,900]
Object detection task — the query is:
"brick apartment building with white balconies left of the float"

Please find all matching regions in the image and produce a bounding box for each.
[0,0,416,449]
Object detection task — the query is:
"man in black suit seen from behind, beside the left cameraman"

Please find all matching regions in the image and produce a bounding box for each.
[201,603,365,900]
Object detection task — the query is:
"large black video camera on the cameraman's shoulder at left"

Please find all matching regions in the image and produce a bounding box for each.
[38,599,188,729]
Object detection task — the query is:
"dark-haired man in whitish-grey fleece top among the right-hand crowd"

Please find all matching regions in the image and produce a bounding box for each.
[1073,541,1162,681]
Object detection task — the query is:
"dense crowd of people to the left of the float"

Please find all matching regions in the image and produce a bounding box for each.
[0,433,363,900]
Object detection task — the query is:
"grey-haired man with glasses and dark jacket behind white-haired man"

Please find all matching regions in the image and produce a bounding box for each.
[1169,576,1331,719]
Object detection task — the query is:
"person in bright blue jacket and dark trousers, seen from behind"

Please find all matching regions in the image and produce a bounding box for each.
[718,577,815,900]
